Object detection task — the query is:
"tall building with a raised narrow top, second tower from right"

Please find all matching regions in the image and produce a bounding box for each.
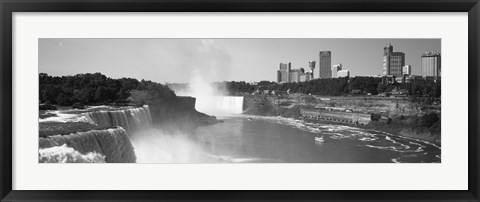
[383,43,405,77]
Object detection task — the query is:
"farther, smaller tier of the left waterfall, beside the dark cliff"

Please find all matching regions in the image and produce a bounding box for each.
[85,105,152,132]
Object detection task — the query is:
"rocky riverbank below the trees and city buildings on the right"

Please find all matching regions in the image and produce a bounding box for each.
[244,95,441,144]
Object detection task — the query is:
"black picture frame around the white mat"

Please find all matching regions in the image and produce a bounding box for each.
[0,0,480,201]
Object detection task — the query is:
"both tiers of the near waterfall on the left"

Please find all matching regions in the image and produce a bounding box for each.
[39,105,152,163]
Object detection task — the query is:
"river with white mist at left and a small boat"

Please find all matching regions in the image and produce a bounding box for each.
[133,115,441,163]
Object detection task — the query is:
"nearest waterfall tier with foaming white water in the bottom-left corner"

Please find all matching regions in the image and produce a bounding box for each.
[39,127,136,163]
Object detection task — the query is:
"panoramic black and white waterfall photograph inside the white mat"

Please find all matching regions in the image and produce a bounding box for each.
[34,38,446,164]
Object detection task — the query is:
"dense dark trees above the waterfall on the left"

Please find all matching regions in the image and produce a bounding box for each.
[39,73,175,106]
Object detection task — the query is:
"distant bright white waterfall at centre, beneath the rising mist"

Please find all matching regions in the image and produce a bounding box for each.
[195,96,243,115]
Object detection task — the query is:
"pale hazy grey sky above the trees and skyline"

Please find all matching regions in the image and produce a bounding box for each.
[39,39,441,83]
